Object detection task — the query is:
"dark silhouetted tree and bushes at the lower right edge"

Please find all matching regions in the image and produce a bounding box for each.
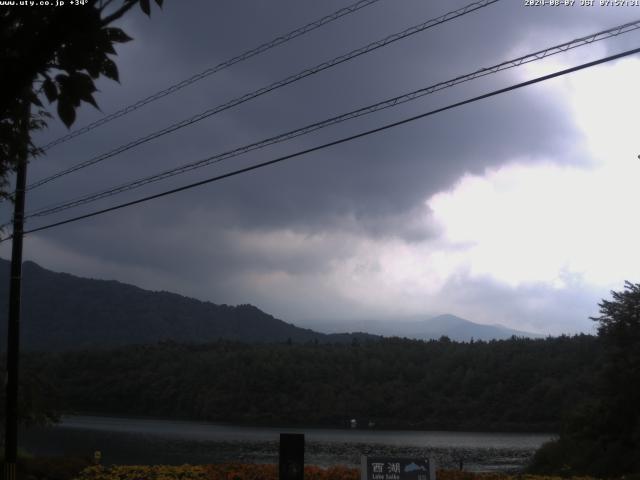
[531,282,640,477]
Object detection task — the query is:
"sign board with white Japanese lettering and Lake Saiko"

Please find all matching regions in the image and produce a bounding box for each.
[360,455,436,480]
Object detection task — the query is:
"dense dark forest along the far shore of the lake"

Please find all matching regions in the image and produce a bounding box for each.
[23,335,600,431]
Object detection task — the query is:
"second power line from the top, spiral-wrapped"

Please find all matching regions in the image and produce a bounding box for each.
[27,0,500,190]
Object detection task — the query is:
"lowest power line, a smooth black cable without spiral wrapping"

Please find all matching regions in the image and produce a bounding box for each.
[10,48,640,243]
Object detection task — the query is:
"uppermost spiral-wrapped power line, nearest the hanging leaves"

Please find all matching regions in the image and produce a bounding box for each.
[41,0,379,151]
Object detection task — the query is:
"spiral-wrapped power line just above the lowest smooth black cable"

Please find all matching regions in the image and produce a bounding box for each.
[20,20,640,218]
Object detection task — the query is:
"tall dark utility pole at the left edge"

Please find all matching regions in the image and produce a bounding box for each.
[3,100,31,480]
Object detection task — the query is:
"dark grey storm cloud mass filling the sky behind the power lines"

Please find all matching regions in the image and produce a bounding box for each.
[2,0,631,326]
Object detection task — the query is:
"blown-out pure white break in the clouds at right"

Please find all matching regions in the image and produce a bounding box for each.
[418,59,640,322]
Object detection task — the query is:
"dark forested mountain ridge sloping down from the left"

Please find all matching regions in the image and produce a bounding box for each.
[0,259,377,350]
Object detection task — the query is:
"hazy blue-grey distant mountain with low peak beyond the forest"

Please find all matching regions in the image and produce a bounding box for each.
[316,314,543,342]
